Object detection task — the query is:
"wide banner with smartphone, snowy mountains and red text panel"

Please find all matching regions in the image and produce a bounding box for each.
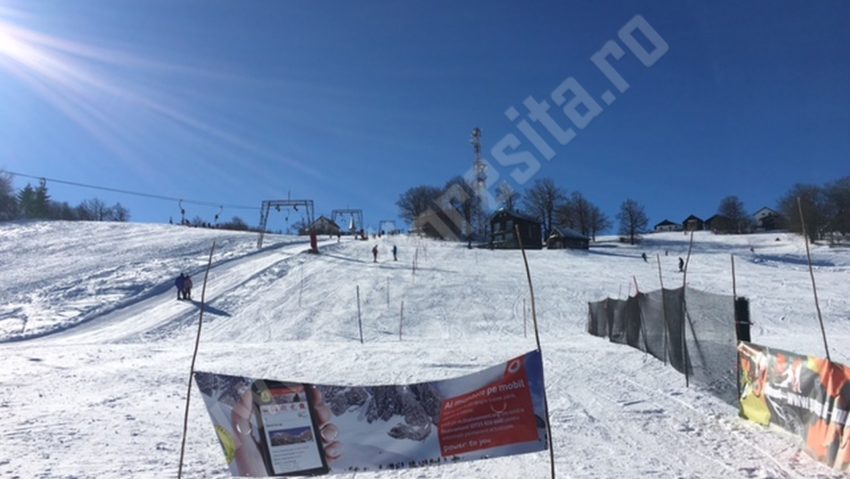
[195,351,547,477]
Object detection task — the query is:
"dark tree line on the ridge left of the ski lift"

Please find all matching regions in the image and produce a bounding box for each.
[0,171,130,221]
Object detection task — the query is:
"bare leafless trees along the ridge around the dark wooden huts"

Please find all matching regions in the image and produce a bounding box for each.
[396,176,850,244]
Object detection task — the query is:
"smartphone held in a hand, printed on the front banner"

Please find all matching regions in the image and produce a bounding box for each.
[253,381,328,476]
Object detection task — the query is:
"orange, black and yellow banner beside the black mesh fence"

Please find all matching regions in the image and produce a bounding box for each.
[738,342,850,472]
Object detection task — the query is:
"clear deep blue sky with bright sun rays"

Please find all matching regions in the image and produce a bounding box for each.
[0,0,850,229]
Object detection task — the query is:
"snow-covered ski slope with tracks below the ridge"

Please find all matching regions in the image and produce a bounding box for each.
[0,222,850,479]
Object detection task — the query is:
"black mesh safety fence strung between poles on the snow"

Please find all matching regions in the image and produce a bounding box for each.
[587,288,749,404]
